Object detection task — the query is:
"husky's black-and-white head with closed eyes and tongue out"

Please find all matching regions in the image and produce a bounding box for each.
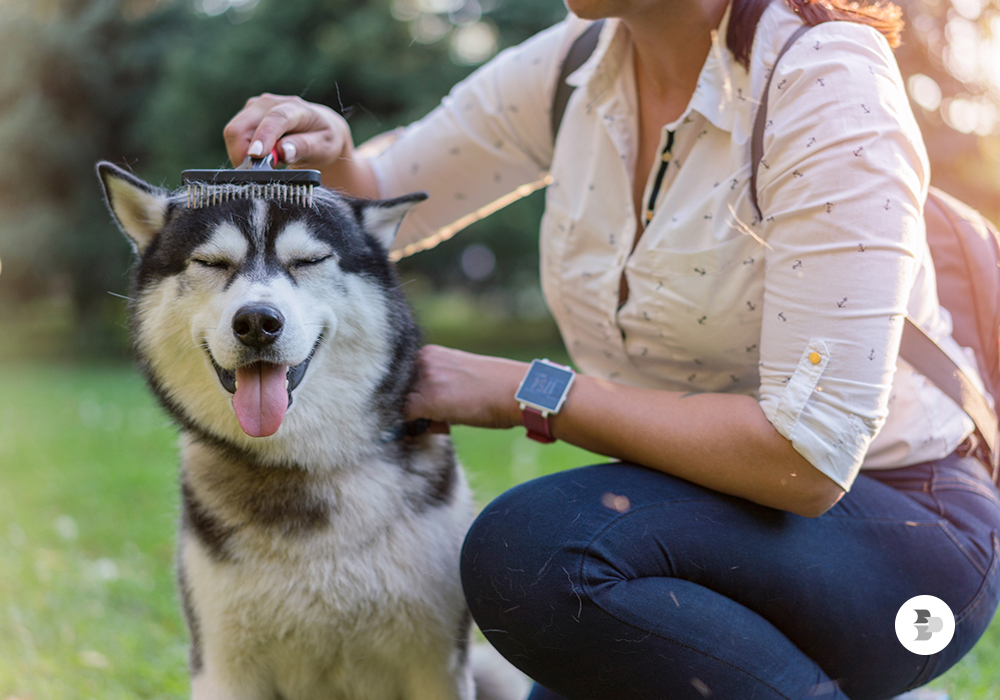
[98,163,426,460]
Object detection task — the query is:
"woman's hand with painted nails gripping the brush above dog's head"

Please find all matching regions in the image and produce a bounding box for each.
[222,93,379,199]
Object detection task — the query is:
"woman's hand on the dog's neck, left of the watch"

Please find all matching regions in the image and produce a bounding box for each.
[406,345,528,428]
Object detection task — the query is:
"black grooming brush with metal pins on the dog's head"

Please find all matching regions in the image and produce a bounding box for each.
[181,147,322,209]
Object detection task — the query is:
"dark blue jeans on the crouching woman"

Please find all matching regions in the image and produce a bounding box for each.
[462,455,1000,700]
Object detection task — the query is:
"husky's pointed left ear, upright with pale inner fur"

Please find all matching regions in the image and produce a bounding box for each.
[97,161,169,255]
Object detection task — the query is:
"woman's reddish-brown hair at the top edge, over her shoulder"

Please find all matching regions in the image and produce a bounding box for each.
[726,0,903,68]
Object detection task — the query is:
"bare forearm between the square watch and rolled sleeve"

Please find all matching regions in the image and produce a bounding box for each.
[550,376,843,516]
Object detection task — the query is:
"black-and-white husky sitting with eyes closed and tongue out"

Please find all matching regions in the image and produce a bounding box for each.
[98,163,528,700]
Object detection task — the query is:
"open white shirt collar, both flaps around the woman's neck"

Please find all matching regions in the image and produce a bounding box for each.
[566,4,750,132]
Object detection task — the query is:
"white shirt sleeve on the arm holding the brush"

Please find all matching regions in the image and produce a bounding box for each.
[369,18,580,254]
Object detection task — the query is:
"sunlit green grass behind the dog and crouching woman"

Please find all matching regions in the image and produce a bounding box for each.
[0,364,1000,700]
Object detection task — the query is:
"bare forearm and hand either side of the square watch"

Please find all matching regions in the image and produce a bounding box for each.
[408,345,844,516]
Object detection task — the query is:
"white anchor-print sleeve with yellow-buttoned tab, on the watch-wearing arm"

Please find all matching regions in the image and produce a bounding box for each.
[758,22,928,490]
